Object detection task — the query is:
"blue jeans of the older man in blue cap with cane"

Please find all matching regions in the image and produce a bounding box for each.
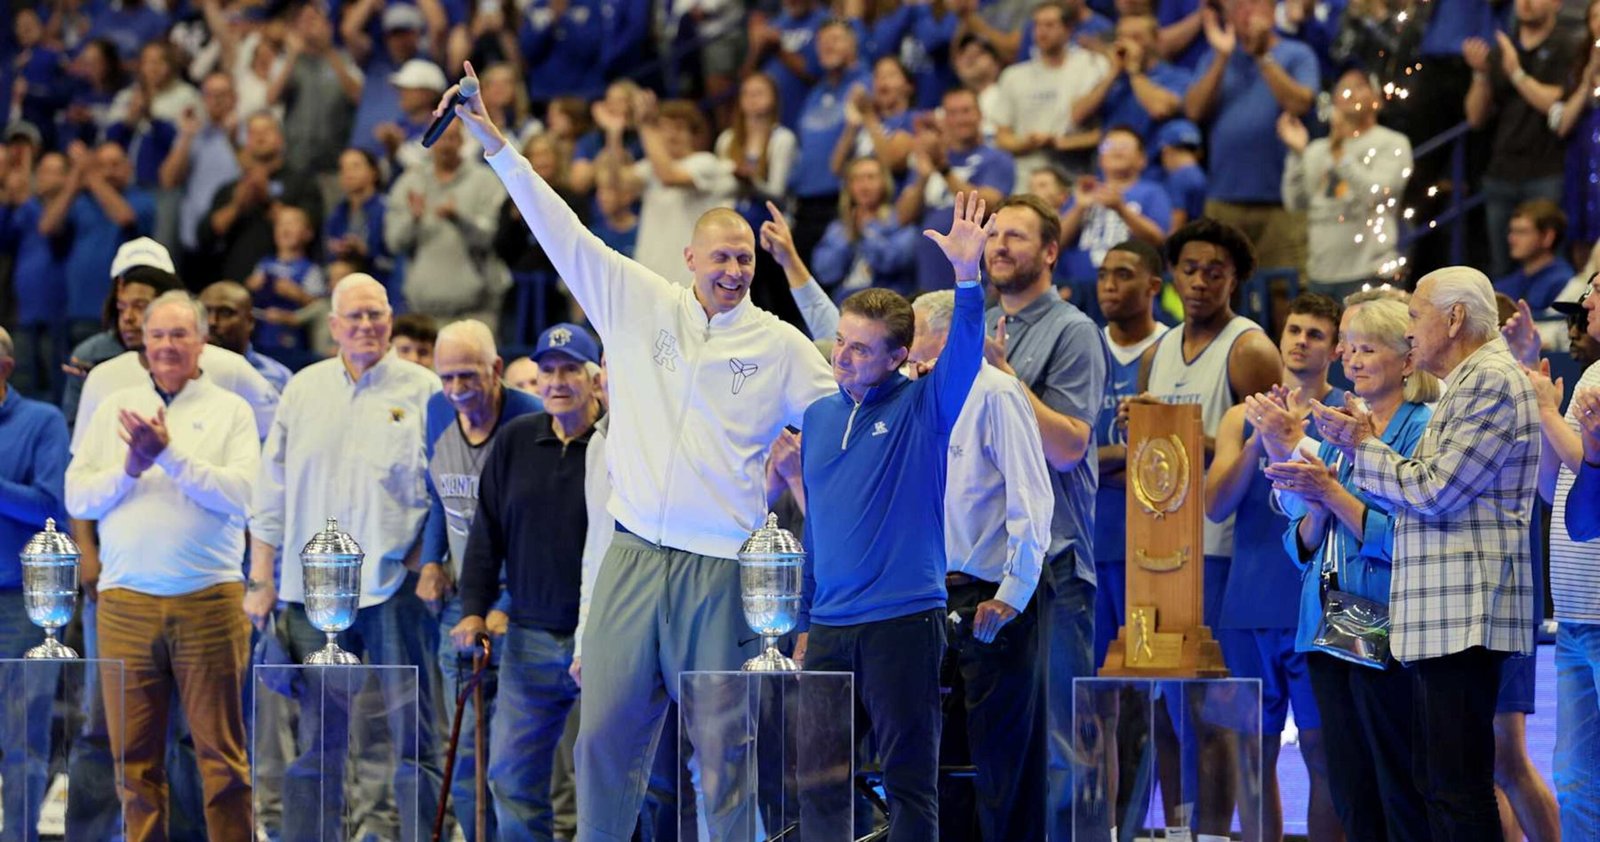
[488,624,578,842]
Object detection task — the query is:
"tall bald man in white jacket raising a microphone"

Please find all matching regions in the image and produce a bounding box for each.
[440,64,837,842]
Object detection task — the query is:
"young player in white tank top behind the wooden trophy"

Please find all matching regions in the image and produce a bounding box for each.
[1118,218,1283,840]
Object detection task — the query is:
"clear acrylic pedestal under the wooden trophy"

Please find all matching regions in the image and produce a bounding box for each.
[1072,677,1262,842]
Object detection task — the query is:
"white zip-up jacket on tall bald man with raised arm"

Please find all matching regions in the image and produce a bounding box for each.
[488,144,838,559]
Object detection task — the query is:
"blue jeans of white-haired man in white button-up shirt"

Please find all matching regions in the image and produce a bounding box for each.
[280,573,443,842]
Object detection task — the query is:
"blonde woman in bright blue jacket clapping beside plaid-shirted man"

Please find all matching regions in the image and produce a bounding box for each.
[1251,299,1438,842]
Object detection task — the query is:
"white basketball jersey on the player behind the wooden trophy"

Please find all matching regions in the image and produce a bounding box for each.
[1149,315,1261,559]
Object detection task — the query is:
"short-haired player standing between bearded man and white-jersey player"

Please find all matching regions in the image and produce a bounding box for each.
[1094,240,1166,666]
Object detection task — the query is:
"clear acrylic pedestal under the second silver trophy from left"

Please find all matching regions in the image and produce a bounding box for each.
[251,664,434,842]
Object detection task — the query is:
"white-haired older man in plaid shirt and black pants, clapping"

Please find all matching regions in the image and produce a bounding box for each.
[1315,266,1539,842]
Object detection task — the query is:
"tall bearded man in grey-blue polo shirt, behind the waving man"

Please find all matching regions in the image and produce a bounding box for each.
[984,195,1109,839]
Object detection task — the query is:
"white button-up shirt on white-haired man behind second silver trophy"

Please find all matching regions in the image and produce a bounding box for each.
[250,355,440,608]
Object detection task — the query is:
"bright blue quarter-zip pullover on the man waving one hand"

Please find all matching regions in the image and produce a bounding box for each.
[800,283,984,629]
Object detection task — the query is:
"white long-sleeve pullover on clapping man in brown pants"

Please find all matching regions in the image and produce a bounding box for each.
[67,376,261,597]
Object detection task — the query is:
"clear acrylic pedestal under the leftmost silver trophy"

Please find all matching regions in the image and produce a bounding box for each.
[0,658,125,842]
